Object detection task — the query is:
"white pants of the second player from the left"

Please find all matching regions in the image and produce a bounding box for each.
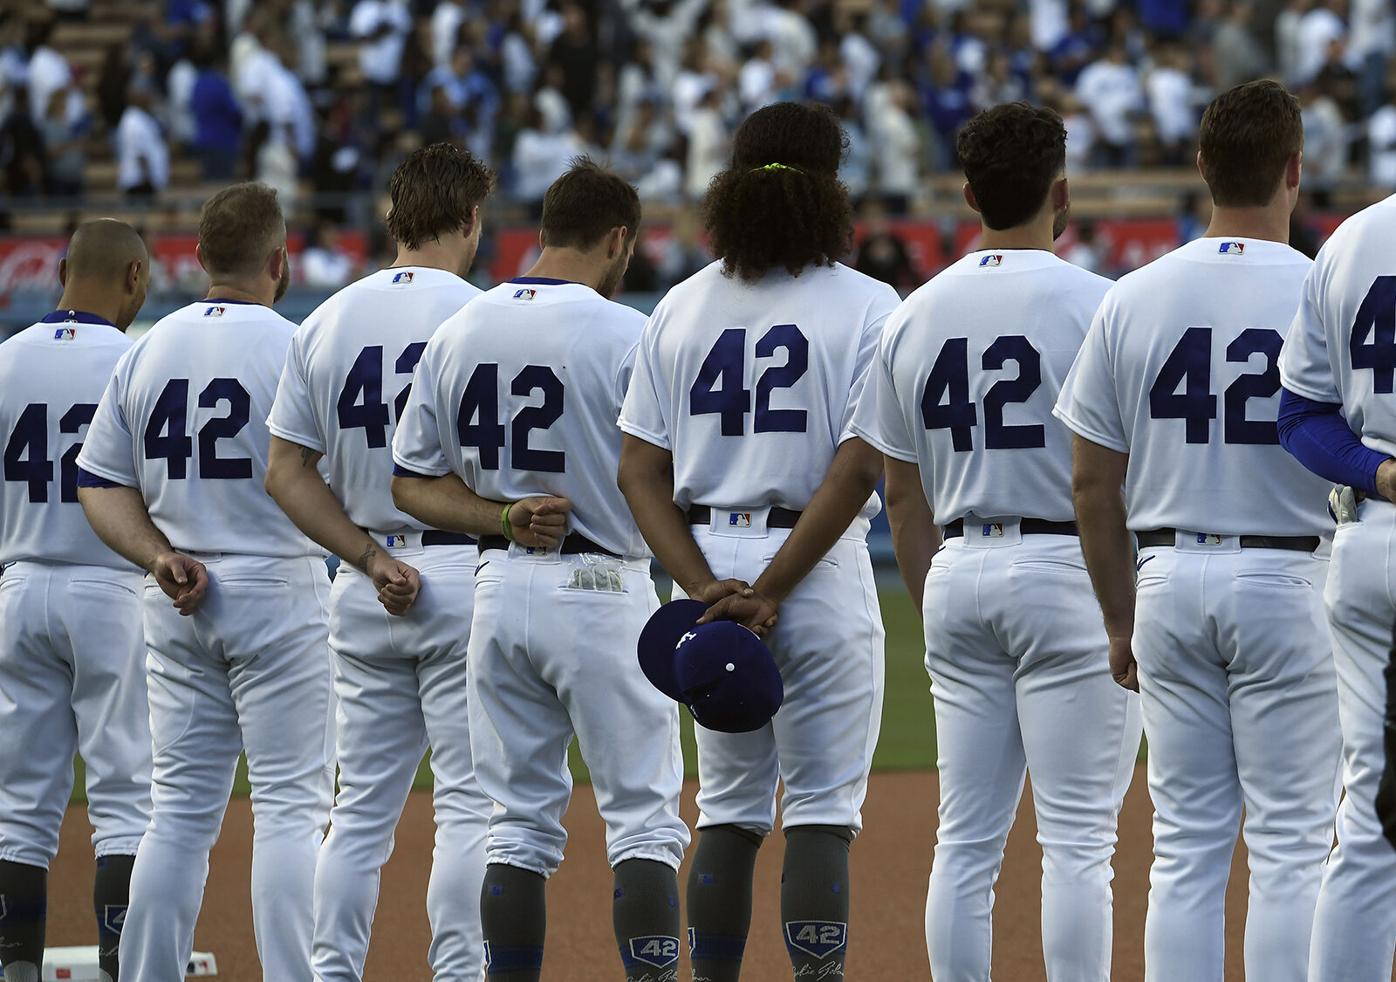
[121,553,334,982]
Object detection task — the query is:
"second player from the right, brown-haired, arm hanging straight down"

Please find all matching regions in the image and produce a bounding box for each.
[1055,81,1343,982]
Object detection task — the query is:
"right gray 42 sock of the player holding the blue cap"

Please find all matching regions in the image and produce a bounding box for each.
[780,826,853,979]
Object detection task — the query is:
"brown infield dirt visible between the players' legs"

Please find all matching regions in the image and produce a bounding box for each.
[49,768,1245,982]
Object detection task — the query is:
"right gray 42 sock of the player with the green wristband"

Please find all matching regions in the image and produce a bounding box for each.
[611,859,678,982]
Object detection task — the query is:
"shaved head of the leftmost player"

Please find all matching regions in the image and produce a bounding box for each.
[59,218,151,331]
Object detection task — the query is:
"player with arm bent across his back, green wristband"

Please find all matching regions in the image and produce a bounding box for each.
[392,161,688,982]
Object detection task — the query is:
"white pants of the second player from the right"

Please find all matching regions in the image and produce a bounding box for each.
[1134,532,1347,982]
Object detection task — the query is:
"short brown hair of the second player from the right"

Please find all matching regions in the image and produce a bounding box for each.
[1198,80,1304,208]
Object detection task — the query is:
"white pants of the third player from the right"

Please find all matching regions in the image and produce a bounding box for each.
[923,522,1141,982]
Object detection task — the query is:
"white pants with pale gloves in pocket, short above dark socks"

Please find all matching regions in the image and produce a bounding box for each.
[469,545,688,876]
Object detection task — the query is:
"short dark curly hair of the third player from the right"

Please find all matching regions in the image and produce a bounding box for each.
[955,102,1067,229]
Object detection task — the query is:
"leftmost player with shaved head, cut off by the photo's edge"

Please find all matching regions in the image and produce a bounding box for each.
[0,219,151,982]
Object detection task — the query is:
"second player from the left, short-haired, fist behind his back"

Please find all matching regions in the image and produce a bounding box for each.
[78,184,334,982]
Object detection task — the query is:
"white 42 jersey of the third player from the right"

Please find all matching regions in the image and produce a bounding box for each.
[853,249,1111,525]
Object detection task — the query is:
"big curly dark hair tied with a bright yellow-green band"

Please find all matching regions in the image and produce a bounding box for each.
[704,102,853,282]
